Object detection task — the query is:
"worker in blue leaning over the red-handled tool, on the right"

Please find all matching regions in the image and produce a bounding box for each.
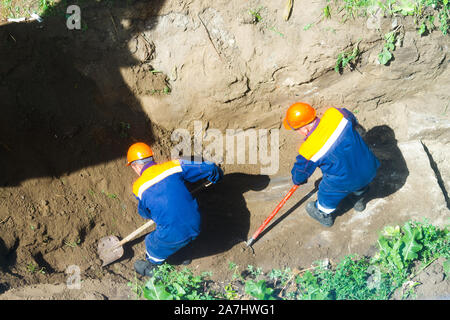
[283,102,380,227]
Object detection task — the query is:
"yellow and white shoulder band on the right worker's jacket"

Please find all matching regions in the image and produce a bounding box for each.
[298,108,348,161]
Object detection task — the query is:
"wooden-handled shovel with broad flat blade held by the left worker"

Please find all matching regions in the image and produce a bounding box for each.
[97,181,212,267]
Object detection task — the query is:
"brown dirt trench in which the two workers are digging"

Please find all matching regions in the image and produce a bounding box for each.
[0,0,450,299]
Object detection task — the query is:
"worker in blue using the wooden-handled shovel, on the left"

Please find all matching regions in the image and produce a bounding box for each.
[127,142,223,276]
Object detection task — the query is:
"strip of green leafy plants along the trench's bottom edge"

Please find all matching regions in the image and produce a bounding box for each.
[135,221,450,300]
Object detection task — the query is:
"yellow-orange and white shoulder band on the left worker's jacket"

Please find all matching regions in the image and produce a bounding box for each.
[133,160,183,199]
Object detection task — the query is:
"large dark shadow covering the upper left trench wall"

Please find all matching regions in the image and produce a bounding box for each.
[0,0,165,186]
